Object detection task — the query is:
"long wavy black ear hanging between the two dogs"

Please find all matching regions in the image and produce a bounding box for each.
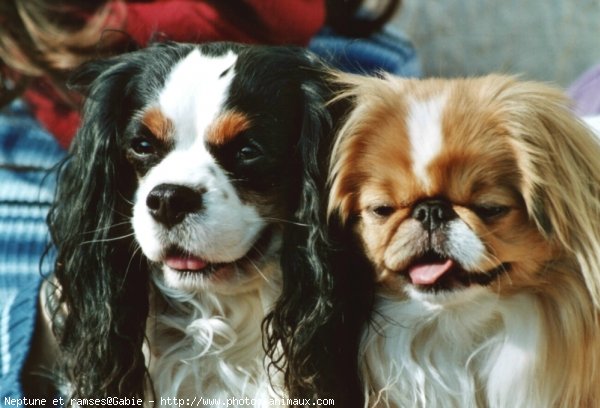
[265,54,360,407]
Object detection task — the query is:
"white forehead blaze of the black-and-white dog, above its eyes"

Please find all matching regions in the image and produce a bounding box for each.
[159,49,237,146]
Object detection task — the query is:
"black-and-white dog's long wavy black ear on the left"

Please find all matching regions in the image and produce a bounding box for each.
[48,52,148,397]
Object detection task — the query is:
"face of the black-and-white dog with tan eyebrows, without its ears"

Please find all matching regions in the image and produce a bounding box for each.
[125,45,315,292]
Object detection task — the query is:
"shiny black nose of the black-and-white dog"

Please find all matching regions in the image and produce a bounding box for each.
[146,184,203,228]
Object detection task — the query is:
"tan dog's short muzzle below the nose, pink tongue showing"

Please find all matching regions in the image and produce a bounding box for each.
[380,217,511,301]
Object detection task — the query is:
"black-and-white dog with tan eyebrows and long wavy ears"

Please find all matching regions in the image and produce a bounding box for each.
[46,43,332,406]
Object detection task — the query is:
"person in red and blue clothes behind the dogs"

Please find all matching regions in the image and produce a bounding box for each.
[0,0,419,400]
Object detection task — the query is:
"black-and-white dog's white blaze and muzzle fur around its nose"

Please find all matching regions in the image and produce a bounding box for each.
[132,49,266,263]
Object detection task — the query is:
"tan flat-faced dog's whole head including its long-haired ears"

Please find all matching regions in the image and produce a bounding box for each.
[328,76,600,303]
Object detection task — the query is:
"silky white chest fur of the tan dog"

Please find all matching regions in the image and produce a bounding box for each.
[361,289,554,408]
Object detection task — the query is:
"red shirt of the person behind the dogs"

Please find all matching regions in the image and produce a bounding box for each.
[24,0,325,147]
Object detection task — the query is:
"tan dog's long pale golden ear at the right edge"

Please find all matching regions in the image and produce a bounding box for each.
[498,82,600,307]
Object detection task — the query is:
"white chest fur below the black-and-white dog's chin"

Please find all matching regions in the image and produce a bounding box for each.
[147,276,277,407]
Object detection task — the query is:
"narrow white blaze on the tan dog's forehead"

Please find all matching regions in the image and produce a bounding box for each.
[407,95,446,187]
